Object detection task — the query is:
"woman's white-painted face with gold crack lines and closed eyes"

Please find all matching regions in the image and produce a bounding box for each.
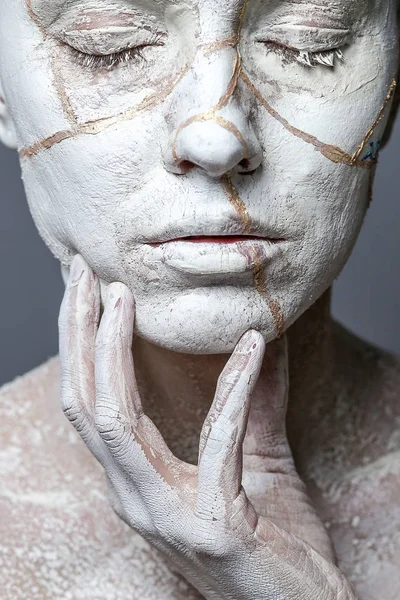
[0,0,397,353]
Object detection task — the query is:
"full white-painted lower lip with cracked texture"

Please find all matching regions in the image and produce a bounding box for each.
[148,236,283,276]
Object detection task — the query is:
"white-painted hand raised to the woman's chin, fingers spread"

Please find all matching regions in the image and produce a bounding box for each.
[60,256,354,600]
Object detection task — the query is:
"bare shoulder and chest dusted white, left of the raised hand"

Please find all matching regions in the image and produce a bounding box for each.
[0,359,199,600]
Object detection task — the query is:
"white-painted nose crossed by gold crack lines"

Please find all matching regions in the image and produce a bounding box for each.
[164,48,262,177]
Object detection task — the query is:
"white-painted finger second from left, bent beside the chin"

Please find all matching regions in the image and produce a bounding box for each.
[95,283,183,486]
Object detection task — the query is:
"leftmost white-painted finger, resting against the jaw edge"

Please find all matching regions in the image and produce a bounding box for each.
[59,255,105,460]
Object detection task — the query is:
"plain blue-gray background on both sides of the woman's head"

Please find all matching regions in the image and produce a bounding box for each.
[0,120,400,385]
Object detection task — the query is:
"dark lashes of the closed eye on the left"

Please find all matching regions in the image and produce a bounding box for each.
[70,35,164,71]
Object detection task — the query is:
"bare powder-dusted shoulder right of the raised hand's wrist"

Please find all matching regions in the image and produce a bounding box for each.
[314,326,400,600]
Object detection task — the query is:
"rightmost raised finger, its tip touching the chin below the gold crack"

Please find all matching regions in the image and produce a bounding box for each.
[198,331,265,510]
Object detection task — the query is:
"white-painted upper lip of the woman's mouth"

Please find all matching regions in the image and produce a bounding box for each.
[136,214,285,244]
